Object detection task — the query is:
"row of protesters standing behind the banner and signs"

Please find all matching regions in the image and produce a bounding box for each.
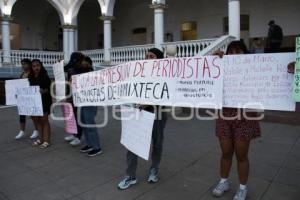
[12,41,293,200]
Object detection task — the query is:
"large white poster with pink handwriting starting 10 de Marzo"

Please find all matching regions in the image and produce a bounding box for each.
[223,53,296,111]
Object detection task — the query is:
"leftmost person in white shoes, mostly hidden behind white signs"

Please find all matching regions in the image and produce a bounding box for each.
[15,58,39,140]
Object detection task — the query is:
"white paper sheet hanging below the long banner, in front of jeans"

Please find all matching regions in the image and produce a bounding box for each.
[121,106,155,160]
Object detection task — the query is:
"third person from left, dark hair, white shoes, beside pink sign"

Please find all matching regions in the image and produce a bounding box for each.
[64,52,84,146]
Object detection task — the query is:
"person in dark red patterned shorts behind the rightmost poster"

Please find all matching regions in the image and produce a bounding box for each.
[212,41,260,200]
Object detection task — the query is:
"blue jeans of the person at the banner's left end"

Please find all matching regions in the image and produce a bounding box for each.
[81,106,100,150]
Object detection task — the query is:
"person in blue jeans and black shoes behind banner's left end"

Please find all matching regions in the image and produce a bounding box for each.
[76,56,102,157]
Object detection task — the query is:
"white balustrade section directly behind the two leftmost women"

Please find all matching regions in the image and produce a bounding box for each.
[11,50,64,66]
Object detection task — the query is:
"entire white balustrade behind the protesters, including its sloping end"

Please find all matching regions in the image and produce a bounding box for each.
[0,35,234,67]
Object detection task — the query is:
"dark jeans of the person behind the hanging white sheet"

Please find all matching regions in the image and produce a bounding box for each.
[126,113,167,177]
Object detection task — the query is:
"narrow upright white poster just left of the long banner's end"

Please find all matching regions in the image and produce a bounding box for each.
[52,60,66,101]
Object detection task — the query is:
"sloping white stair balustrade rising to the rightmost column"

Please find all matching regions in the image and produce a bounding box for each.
[199,35,235,56]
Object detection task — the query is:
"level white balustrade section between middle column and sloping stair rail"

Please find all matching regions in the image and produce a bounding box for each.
[162,38,217,57]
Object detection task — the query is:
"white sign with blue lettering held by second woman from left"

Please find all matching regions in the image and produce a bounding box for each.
[17,86,43,116]
